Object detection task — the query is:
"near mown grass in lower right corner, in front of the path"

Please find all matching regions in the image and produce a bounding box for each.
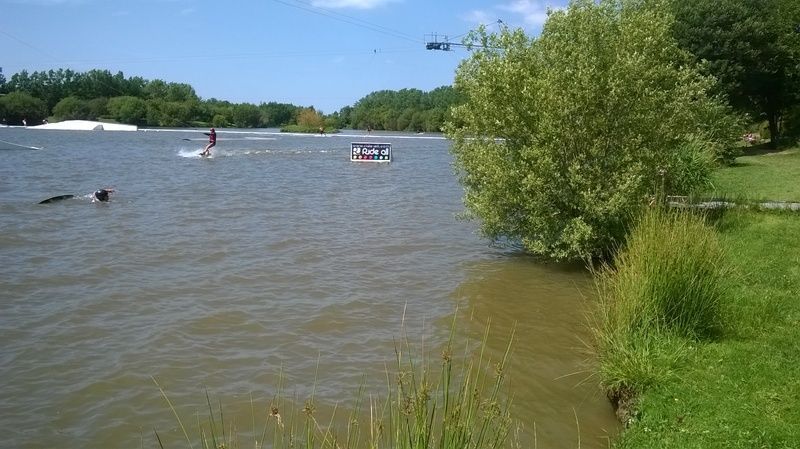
[617,213,800,448]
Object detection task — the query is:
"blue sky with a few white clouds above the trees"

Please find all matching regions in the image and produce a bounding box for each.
[0,0,566,113]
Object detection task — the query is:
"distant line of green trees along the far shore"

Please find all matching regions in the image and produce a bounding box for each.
[0,69,458,131]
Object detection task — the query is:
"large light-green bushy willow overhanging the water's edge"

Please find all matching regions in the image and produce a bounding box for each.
[447,0,737,260]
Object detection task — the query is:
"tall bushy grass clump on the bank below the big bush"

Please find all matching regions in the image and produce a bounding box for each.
[592,208,728,421]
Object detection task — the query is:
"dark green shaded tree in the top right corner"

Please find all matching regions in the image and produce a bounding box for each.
[672,0,800,145]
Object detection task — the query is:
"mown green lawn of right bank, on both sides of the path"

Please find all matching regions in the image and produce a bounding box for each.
[603,148,800,448]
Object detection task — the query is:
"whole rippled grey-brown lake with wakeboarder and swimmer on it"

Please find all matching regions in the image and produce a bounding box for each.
[0,128,618,448]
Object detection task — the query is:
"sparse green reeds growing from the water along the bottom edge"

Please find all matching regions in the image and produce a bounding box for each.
[153,319,513,449]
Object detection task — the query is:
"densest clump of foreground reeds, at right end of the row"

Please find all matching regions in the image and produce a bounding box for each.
[384,326,511,449]
